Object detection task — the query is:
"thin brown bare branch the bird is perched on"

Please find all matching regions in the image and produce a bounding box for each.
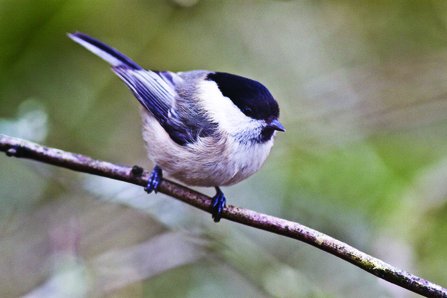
[0,135,447,297]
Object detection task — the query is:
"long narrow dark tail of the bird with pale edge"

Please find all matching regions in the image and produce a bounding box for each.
[68,32,143,70]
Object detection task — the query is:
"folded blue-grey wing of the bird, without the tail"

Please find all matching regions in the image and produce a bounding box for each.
[112,65,210,146]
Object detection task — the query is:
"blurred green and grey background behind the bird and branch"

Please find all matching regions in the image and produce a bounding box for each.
[0,0,447,297]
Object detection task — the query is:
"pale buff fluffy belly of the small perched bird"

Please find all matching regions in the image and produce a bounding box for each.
[143,115,273,187]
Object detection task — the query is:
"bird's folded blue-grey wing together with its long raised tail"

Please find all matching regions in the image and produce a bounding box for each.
[68,32,203,145]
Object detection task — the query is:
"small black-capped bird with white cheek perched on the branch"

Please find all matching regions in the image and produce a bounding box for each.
[68,32,285,222]
